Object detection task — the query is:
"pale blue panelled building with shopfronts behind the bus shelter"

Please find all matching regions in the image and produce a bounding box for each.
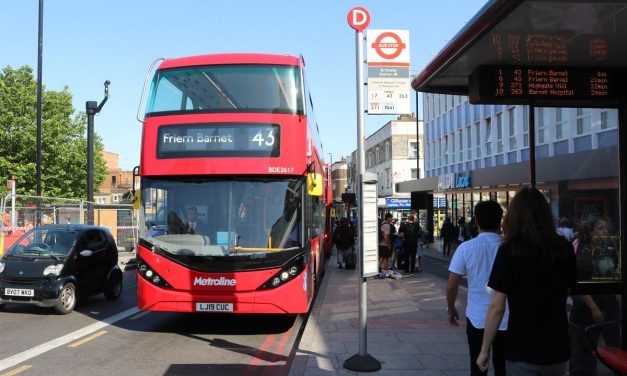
[398,93,620,262]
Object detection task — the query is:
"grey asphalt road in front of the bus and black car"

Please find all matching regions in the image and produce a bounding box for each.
[0,271,306,376]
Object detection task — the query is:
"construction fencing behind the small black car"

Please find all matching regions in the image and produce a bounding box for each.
[0,194,139,251]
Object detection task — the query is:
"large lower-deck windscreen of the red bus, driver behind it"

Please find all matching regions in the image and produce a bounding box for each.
[141,177,304,257]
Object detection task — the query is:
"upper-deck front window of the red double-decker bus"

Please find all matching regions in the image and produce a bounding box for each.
[146,64,304,116]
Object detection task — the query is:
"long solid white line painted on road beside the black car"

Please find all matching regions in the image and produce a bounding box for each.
[0,307,139,371]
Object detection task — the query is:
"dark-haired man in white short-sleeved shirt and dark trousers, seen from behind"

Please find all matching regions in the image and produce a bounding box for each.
[446,201,508,376]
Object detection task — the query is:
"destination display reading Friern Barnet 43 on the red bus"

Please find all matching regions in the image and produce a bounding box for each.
[157,123,281,159]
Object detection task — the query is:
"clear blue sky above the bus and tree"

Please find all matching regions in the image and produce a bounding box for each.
[0,0,486,169]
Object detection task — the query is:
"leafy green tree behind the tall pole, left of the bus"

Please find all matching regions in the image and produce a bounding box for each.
[0,66,106,199]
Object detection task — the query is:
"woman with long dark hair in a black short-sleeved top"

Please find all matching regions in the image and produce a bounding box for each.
[477,188,577,376]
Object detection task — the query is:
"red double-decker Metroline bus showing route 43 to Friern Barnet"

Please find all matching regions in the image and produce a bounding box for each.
[137,54,331,314]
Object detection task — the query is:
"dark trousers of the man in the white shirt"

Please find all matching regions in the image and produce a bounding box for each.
[466,318,507,376]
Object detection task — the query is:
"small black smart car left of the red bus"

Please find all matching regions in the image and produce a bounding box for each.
[0,224,122,314]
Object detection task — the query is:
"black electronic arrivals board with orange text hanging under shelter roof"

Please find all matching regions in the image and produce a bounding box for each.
[469,66,626,107]
